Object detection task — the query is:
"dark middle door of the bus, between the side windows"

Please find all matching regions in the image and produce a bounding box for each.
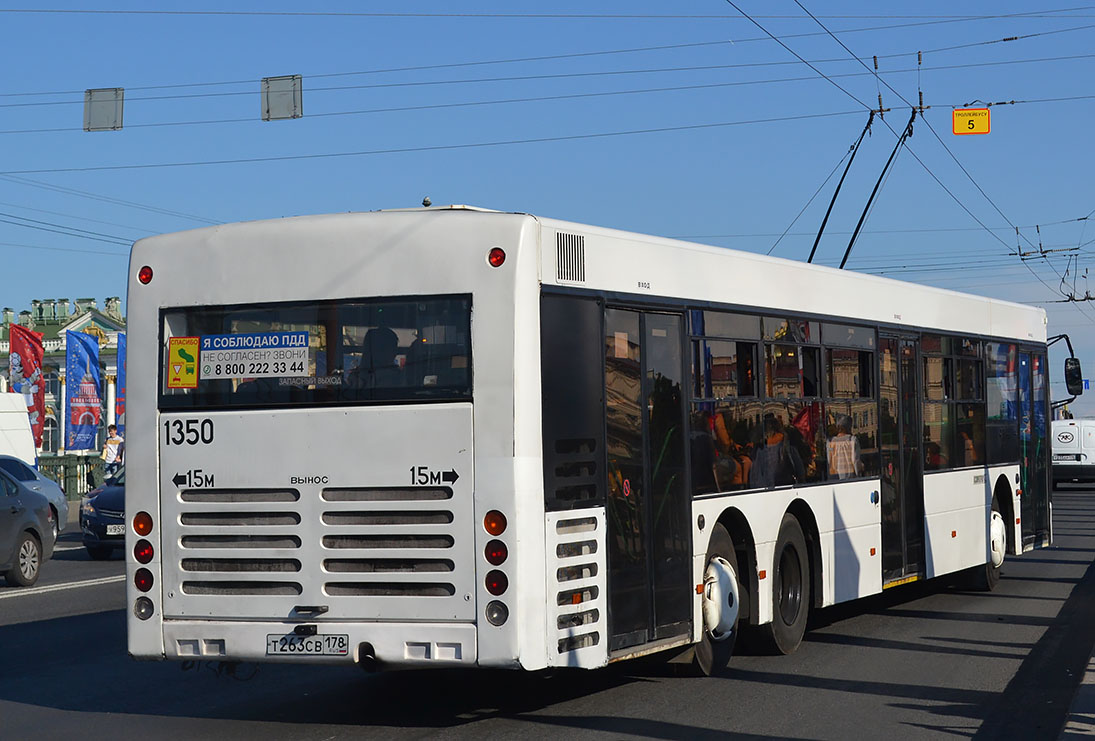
[879,335,924,587]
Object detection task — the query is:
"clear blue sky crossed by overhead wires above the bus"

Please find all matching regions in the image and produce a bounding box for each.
[0,0,1095,414]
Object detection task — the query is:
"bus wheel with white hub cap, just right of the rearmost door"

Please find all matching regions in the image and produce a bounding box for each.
[695,523,740,676]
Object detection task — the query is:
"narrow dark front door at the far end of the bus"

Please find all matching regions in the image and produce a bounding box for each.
[1018,350,1049,547]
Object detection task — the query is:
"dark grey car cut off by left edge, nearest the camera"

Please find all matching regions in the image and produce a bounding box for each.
[0,471,57,587]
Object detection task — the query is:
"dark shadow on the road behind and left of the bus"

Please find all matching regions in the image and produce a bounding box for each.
[0,610,644,730]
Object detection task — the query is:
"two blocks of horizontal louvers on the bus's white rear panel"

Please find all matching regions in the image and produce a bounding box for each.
[178,487,457,599]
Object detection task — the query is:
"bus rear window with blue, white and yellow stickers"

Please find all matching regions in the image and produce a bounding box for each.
[160,296,472,409]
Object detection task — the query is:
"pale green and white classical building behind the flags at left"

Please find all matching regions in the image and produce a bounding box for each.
[0,297,126,454]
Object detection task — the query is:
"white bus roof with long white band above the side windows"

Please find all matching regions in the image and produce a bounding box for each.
[135,205,1047,343]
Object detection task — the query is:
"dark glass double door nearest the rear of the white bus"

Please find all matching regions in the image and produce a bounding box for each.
[604,309,692,651]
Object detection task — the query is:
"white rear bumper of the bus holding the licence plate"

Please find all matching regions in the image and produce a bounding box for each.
[163,620,477,669]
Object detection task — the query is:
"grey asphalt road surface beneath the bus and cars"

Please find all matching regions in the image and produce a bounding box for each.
[0,490,1095,740]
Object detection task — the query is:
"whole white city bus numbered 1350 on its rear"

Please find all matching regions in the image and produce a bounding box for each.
[126,207,1068,673]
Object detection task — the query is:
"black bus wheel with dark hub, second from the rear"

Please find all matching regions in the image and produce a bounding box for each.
[762,513,810,653]
